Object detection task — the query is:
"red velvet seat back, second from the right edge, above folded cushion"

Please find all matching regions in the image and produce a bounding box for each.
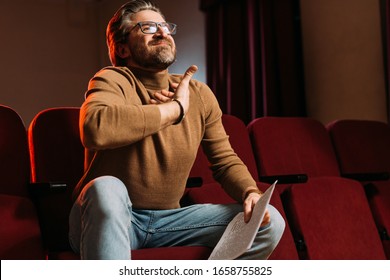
[248,117,339,177]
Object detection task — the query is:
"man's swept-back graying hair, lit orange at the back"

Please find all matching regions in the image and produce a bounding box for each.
[106,0,164,66]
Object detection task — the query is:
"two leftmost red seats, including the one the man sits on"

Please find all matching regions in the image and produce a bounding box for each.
[0,106,211,260]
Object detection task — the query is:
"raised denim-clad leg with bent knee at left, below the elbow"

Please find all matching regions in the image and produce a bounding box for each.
[69,176,132,259]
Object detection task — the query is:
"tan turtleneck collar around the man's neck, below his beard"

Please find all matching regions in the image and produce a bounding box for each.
[129,68,169,90]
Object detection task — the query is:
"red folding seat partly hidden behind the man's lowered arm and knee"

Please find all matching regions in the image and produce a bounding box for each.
[187,114,298,260]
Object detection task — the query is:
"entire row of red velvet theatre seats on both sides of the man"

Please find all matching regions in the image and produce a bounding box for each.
[0,106,390,260]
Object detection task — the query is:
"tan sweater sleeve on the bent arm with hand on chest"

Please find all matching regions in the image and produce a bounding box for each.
[80,68,161,150]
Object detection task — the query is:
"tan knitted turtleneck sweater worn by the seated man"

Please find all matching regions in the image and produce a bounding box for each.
[74,67,256,209]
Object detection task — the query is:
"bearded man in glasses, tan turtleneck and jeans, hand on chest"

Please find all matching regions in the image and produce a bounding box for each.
[69,0,284,259]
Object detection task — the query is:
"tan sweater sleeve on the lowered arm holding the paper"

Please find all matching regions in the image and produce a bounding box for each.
[198,82,256,202]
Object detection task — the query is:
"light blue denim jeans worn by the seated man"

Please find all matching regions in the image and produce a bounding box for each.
[69,176,285,260]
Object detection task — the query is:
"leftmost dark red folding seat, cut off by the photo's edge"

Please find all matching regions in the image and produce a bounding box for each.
[0,105,45,260]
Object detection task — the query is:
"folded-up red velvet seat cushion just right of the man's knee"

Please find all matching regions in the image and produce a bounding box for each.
[286,177,385,260]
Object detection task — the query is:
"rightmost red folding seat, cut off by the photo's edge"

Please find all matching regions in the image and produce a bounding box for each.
[327,120,390,259]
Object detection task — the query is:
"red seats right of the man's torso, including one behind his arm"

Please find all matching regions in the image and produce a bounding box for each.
[189,115,390,259]
